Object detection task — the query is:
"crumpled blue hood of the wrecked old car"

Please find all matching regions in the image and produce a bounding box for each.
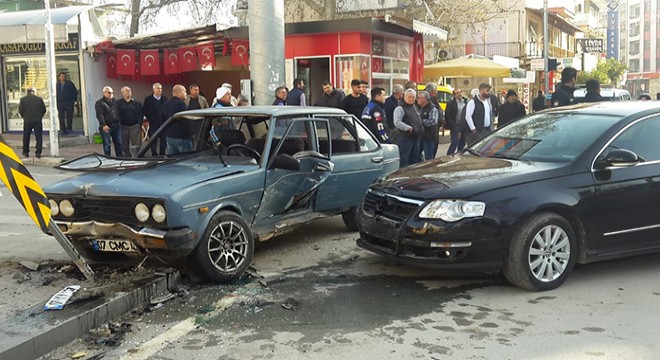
[44,156,258,197]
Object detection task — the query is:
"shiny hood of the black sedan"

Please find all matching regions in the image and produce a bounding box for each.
[375,155,570,199]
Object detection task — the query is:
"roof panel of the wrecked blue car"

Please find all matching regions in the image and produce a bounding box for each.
[175,105,347,118]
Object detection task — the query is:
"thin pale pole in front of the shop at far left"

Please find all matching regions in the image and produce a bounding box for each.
[44,0,60,156]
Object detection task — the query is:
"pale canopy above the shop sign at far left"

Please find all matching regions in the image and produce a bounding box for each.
[0,6,94,44]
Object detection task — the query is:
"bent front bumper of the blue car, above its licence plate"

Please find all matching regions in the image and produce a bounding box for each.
[55,221,194,256]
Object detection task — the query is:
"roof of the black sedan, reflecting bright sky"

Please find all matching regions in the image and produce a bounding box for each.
[546,101,660,117]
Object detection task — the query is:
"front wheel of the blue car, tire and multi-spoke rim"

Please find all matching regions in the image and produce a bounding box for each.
[192,211,254,283]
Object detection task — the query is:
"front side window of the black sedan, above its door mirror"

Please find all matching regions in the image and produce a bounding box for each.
[609,116,660,161]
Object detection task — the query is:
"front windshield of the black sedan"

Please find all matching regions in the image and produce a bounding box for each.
[472,112,621,162]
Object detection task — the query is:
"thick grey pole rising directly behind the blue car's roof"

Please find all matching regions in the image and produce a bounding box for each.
[248,0,286,105]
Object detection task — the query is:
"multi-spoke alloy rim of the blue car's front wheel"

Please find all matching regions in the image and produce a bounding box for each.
[208,221,248,272]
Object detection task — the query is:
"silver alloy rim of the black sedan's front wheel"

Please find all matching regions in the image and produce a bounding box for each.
[528,225,571,282]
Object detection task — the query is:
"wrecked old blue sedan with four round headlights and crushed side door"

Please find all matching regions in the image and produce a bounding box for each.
[45,106,399,282]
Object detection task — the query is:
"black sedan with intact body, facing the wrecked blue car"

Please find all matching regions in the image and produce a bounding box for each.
[357,102,660,291]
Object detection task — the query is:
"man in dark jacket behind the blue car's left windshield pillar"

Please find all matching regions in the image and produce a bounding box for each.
[163,84,193,155]
